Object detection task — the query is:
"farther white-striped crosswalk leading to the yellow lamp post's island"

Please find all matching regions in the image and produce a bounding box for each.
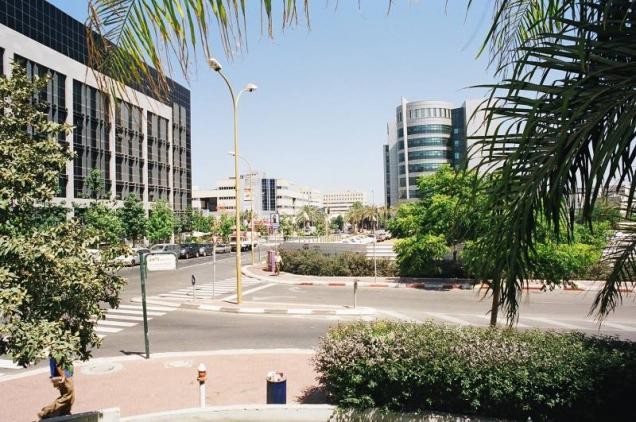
[147,277,263,304]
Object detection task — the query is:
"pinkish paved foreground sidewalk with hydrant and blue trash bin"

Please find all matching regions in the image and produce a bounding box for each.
[0,349,324,421]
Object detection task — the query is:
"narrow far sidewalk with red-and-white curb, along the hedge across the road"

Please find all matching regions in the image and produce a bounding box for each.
[242,264,636,293]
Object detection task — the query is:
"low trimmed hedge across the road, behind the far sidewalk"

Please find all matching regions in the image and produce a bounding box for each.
[281,249,397,277]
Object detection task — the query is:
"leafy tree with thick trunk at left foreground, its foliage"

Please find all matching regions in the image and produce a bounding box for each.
[0,65,125,367]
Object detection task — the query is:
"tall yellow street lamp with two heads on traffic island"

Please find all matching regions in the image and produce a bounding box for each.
[208,57,256,303]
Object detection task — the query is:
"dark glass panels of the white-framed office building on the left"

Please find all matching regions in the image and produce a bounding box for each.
[0,0,192,212]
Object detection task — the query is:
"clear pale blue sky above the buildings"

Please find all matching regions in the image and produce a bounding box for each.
[49,0,493,204]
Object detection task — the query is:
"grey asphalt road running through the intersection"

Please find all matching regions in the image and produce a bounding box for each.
[0,253,636,378]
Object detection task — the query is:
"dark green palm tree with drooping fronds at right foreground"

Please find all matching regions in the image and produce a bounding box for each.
[474,0,636,322]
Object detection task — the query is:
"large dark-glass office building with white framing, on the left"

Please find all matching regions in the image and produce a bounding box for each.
[0,0,192,212]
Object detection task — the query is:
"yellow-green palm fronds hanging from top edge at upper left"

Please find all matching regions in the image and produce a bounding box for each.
[87,0,309,94]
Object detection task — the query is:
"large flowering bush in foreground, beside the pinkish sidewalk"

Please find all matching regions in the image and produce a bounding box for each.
[314,321,636,421]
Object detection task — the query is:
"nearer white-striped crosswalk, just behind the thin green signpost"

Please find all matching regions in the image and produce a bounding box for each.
[95,303,179,338]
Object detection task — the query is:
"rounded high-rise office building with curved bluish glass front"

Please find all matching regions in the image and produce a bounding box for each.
[382,98,484,206]
